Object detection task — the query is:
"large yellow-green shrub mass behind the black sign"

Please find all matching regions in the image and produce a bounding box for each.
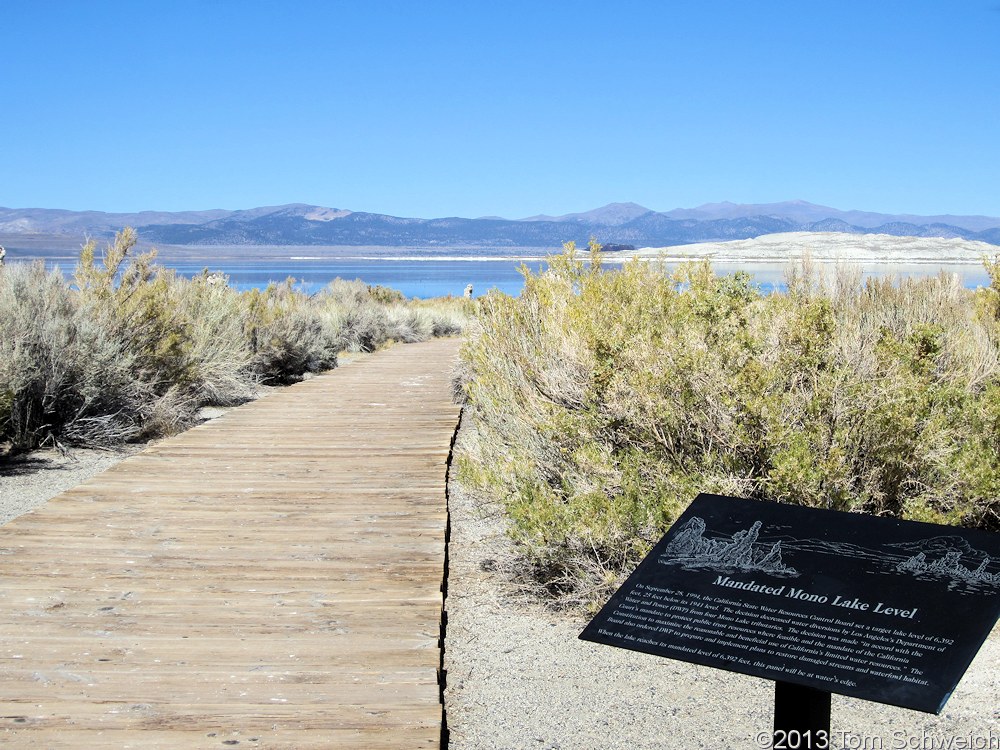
[459,246,1000,601]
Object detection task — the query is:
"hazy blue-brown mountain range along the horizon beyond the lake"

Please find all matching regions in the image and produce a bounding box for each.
[0,201,1000,248]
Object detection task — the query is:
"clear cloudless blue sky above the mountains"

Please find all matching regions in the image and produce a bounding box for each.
[0,0,1000,218]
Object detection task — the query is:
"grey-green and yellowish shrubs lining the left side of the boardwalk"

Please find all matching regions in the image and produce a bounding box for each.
[0,229,462,451]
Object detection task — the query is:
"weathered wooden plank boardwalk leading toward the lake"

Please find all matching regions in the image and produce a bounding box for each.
[0,339,459,750]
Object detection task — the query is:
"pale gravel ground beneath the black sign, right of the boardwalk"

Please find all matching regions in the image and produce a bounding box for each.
[445,427,1000,750]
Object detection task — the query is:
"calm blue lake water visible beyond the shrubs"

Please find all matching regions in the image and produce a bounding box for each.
[21,246,990,298]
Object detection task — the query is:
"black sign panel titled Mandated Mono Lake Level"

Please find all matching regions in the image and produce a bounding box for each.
[580,494,1000,713]
